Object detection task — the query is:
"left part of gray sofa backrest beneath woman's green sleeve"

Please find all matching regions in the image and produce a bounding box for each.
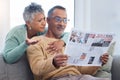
[0,54,34,80]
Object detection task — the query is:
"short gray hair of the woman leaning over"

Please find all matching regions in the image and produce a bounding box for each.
[23,3,44,22]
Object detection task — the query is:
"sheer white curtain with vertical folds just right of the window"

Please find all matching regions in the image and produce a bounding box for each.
[74,0,91,31]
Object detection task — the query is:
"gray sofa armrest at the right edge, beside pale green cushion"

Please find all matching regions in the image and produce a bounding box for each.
[111,54,120,80]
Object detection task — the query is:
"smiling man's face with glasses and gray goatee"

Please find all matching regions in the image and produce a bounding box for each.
[48,9,67,38]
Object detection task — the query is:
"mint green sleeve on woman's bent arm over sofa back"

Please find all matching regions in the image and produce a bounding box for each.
[3,31,28,64]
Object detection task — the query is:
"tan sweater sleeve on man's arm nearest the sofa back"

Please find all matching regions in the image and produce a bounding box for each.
[27,45,56,76]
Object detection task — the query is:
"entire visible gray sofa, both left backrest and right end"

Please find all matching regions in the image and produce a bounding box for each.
[0,54,120,80]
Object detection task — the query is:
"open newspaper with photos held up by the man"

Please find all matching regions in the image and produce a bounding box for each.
[65,29,113,66]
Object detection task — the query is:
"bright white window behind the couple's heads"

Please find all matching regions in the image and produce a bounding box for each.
[10,0,74,31]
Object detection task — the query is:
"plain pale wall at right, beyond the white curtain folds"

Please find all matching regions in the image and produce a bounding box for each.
[91,0,120,54]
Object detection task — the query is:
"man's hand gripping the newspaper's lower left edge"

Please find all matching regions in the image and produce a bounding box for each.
[53,53,68,68]
